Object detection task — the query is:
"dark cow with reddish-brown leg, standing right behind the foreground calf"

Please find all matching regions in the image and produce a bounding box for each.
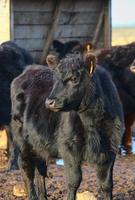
[97,43,135,153]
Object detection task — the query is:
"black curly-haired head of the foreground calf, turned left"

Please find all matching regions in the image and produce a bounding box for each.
[46,52,96,111]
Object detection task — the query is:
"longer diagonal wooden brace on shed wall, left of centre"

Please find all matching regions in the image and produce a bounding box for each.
[40,0,61,65]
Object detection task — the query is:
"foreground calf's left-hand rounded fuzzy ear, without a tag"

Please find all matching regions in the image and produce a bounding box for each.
[46,54,59,69]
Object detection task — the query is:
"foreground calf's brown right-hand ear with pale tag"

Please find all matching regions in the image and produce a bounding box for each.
[84,52,97,75]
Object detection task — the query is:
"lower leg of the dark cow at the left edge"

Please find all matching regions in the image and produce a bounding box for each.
[5,126,19,170]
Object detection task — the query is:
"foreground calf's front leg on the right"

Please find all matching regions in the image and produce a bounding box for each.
[97,154,115,200]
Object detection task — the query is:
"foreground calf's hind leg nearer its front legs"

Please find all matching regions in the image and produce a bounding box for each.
[35,158,47,200]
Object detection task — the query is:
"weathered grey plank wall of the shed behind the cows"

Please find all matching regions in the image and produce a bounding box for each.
[11,0,110,59]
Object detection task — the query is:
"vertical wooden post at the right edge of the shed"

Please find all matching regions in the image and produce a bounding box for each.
[104,0,112,48]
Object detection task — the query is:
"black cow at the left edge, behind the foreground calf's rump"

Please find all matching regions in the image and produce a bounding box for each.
[0,41,33,169]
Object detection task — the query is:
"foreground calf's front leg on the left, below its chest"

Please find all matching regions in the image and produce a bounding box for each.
[62,150,82,200]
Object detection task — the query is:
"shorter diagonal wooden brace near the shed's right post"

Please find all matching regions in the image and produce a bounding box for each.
[92,8,104,47]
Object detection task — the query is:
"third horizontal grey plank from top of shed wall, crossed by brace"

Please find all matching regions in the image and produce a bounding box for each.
[14,24,95,39]
